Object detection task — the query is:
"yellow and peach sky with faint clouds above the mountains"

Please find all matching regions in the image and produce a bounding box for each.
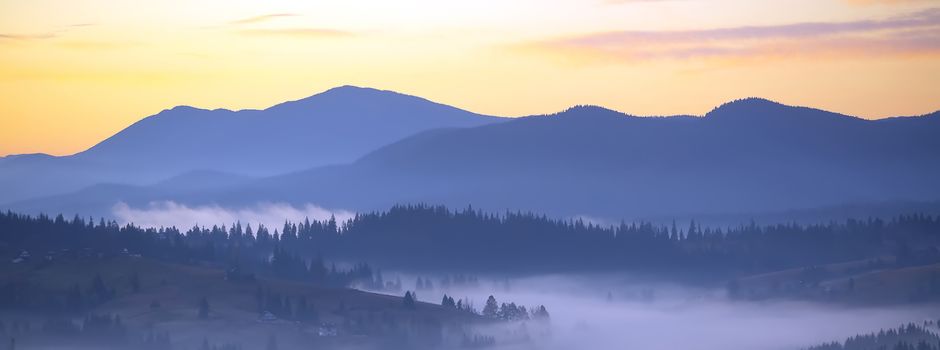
[0,0,940,155]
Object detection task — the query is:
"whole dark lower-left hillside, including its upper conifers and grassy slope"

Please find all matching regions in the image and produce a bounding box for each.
[0,213,560,350]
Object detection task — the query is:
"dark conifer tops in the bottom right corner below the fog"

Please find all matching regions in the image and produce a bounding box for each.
[806,323,940,350]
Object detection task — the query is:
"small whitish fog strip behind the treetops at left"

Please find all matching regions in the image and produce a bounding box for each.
[111,201,355,230]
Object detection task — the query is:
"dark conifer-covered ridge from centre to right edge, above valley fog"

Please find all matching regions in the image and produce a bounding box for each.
[332,205,940,273]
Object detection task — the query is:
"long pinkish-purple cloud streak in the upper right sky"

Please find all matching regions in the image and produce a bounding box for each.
[520,9,940,61]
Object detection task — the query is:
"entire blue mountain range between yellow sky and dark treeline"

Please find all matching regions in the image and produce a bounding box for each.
[0,87,940,220]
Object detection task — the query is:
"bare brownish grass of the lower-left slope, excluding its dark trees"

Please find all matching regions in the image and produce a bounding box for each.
[0,257,480,348]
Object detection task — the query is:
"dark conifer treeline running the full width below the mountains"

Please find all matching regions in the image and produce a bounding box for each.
[0,205,940,283]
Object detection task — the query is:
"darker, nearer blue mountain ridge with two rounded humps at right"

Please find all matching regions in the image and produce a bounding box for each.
[14,98,940,220]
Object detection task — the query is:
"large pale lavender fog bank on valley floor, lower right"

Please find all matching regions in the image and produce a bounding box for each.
[368,275,940,350]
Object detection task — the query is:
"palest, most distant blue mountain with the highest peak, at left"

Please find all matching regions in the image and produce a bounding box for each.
[0,86,502,203]
